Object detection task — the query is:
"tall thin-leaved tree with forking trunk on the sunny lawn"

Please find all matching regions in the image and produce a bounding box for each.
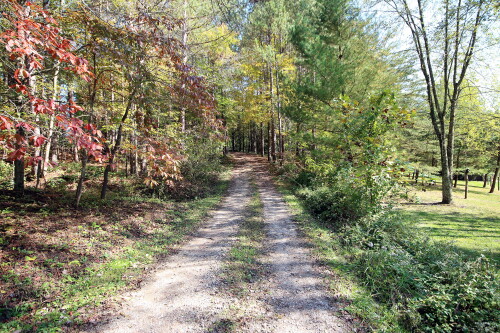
[385,0,493,204]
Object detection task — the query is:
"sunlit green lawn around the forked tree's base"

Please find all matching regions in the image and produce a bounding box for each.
[401,181,500,263]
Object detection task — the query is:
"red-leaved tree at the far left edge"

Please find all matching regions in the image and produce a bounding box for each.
[0,0,102,193]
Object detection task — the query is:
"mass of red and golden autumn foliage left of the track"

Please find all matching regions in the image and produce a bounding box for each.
[0,0,222,198]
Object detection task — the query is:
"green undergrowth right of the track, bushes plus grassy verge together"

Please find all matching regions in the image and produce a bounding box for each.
[276,172,500,332]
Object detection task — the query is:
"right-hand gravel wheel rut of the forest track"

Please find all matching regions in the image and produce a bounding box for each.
[243,160,352,333]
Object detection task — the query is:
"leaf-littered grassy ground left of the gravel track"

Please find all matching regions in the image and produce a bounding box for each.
[0,170,229,332]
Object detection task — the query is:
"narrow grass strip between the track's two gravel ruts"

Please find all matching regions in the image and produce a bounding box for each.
[224,182,266,297]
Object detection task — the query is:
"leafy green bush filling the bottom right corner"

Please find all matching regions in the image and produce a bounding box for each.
[411,257,500,332]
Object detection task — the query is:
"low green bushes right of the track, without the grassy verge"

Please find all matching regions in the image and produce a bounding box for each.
[297,181,500,332]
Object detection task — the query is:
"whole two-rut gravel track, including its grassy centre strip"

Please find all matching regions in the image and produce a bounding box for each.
[87,154,355,332]
